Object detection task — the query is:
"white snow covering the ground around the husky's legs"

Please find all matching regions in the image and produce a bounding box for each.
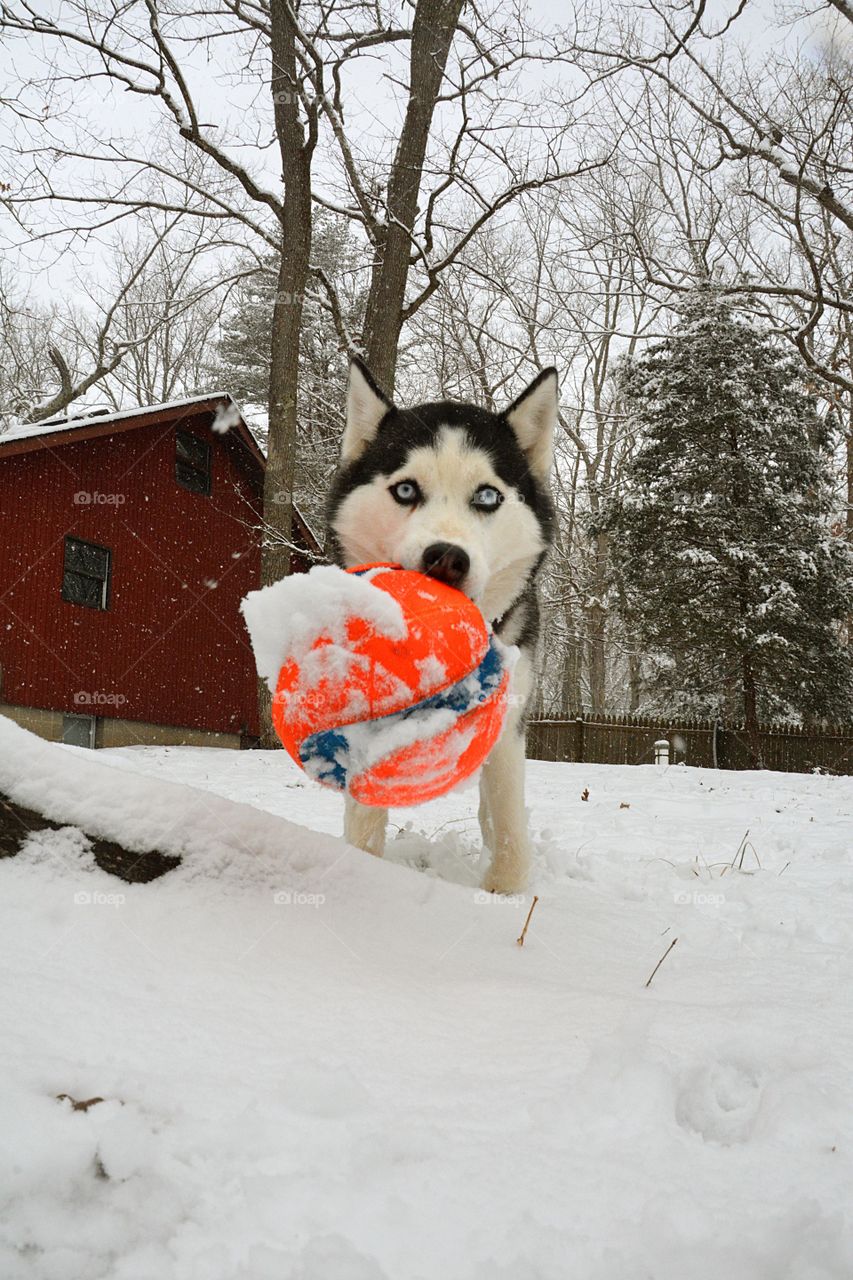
[0,721,853,1280]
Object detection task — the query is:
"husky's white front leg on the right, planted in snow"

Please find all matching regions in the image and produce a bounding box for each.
[480,716,530,893]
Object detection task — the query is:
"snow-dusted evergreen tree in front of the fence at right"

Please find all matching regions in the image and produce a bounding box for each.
[606,288,853,755]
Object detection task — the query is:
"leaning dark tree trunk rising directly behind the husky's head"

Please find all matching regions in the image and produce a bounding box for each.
[364,0,464,396]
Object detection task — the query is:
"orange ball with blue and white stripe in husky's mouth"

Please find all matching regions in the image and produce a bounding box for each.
[273,564,510,806]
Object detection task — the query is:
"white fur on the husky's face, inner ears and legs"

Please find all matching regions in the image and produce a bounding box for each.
[334,365,557,893]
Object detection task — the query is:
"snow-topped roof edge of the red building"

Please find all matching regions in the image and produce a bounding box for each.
[0,392,323,554]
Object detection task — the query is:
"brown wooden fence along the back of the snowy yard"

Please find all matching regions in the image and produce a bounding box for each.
[528,714,853,774]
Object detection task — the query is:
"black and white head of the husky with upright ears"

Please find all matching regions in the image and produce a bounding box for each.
[329,360,557,618]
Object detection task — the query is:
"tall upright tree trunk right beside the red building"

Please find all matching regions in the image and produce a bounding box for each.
[259,0,314,746]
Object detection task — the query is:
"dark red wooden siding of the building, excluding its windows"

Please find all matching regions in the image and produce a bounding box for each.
[0,407,263,733]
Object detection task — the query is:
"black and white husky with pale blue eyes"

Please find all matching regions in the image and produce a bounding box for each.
[328,360,557,893]
